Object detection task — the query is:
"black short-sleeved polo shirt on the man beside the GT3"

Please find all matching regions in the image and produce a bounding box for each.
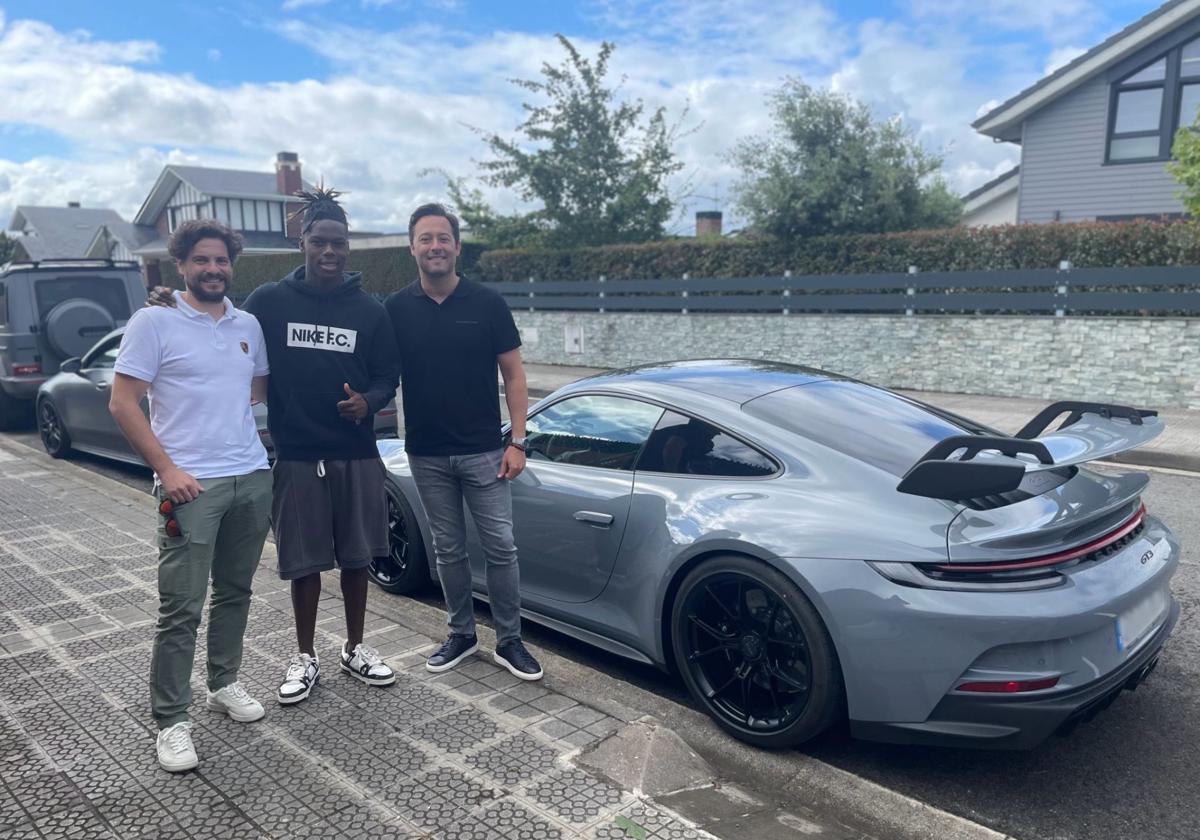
[384,277,521,455]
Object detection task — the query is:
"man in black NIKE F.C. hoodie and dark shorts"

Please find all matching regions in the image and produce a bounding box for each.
[244,190,398,704]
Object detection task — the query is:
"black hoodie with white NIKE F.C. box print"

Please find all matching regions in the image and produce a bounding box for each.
[242,265,400,461]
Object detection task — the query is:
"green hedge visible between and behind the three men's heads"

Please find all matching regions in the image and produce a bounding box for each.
[158,242,484,295]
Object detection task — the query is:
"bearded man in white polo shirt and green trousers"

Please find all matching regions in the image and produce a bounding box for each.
[109,220,271,772]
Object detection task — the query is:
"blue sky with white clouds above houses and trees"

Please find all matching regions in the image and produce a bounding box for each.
[0,0,1158,232]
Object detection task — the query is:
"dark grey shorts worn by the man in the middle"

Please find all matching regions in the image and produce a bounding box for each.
[271,458,388,581]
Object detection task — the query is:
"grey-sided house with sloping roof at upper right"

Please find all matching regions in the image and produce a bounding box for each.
[964,0,1200,224]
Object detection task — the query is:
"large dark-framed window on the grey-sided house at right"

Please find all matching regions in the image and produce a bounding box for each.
[1108,38,1200,163]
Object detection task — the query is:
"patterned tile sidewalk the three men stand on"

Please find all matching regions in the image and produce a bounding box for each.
[0,439,883,840]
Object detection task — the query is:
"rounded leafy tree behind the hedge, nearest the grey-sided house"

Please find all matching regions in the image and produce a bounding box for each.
[730,78,961,239]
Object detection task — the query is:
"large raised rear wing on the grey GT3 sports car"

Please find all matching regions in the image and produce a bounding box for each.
[896,402,1164,500]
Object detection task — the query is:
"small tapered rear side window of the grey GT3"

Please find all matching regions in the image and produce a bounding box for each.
[637,412,776,478]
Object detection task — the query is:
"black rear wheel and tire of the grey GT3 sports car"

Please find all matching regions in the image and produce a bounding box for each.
[671,554,845,749]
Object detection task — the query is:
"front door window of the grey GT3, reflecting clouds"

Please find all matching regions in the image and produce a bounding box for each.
[526,396,662,469]
